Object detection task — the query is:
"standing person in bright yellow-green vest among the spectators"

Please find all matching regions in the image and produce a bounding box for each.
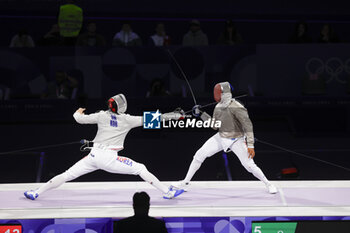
[58,0,83,46]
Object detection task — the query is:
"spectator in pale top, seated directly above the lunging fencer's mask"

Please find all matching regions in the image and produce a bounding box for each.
[113,22,142,47]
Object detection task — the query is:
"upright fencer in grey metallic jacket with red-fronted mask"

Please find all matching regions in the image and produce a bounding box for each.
[172,82,277,194]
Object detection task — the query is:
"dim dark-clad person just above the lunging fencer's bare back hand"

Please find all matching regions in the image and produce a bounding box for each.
[43,71,79,99]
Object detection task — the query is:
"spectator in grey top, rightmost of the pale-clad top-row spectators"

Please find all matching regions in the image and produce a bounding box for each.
[182,19,208,46]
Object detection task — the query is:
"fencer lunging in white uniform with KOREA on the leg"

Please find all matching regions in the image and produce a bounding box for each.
[24,94,183,200]
